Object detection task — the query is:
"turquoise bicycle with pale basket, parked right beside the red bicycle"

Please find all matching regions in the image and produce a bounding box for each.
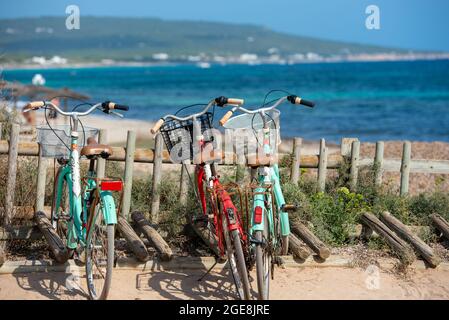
[220,95,315,300]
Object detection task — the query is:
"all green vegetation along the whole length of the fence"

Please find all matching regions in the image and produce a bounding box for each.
[0,132,449,249]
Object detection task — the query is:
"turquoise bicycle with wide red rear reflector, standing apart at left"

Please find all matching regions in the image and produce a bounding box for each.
[23,101,128,300]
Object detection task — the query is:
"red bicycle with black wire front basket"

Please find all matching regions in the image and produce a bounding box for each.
[151,96,251,300]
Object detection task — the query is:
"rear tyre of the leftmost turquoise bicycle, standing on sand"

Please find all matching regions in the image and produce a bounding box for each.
[85,203,115,300]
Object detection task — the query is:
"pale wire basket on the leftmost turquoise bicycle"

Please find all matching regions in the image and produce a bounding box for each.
[36,124,98,158]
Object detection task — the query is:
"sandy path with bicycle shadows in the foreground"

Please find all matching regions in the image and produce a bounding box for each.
[0,268,449,300]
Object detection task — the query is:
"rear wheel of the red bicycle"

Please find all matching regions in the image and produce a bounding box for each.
[223,217,251,300]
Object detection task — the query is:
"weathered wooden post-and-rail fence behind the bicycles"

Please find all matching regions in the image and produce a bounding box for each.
[0,124,449,225]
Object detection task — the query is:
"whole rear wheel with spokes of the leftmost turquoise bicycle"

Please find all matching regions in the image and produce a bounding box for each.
[86,203,114,300]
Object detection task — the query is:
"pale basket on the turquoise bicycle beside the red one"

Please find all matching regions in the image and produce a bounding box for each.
[223,109,281,145]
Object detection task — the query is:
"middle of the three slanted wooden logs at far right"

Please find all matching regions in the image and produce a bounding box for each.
[381,211,441,268]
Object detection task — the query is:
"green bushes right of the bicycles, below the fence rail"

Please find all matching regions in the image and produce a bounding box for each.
[283,159,449,247]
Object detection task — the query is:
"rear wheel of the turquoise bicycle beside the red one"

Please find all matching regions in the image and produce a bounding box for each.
[254,214,271,300]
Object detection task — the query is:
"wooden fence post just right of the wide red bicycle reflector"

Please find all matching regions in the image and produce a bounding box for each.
[121,130,136,220]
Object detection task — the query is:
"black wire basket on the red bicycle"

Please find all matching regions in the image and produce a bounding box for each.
[160,112,212,161]
